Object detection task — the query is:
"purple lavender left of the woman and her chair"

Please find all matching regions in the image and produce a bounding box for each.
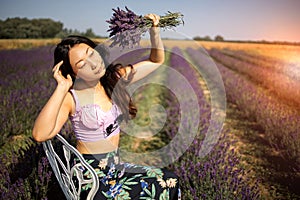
[0,47,64,199]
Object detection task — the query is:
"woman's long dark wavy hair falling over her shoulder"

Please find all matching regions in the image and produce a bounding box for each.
[54,35,137,121]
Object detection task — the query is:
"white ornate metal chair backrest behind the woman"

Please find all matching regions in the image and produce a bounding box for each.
[43,134,99,200]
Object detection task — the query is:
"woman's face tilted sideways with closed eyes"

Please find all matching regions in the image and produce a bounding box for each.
[69,43,105,81]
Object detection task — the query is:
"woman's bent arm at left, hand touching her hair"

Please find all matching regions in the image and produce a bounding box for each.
[32,61,73,142]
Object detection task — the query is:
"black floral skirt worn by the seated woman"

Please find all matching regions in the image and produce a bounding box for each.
[80,149,181,200]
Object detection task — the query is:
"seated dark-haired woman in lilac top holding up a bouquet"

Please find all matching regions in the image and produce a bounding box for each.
[32,14,180,199]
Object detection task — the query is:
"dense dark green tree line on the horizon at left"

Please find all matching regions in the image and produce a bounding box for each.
[0,17,100,39]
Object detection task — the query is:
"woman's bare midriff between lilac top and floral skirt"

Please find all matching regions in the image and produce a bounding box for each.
[76,134,120,154]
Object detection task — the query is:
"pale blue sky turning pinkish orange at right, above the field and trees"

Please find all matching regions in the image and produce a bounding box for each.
[0,0,300,42]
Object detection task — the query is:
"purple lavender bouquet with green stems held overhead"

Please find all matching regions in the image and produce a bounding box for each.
[106,6,184,48]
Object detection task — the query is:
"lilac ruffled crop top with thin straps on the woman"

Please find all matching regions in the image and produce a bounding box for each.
[70,89,122,142]
